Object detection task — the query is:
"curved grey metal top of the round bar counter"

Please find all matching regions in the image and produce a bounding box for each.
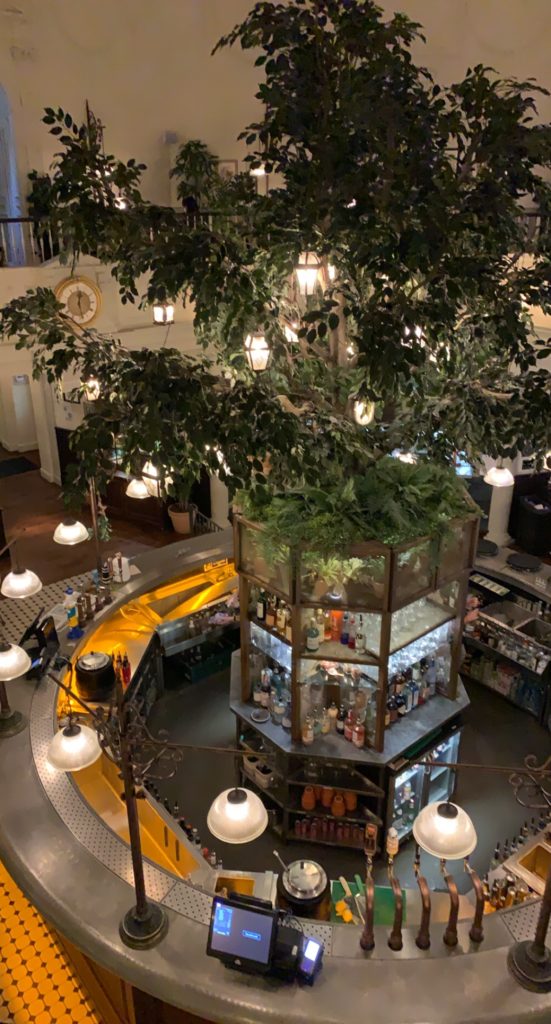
[0,530,551,1024]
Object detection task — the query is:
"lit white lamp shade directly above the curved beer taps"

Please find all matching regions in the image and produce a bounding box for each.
[413,802,476,860]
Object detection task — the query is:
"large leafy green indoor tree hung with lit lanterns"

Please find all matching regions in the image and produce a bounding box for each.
[2,0,551,547]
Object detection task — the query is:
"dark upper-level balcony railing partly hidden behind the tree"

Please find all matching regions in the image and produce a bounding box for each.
[0,210,551,267]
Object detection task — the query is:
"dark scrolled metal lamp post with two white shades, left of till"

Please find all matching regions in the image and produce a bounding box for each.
[48,673,268,949]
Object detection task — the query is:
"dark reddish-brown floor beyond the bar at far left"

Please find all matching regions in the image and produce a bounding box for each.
[0,446,175,584]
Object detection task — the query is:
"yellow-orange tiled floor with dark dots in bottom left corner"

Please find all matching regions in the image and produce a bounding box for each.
[0,864,101,1024]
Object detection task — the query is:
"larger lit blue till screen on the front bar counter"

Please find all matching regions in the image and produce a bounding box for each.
[209,900,276,964]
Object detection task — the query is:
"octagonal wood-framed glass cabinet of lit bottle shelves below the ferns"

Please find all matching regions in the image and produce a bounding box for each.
[235,516,478,753]
